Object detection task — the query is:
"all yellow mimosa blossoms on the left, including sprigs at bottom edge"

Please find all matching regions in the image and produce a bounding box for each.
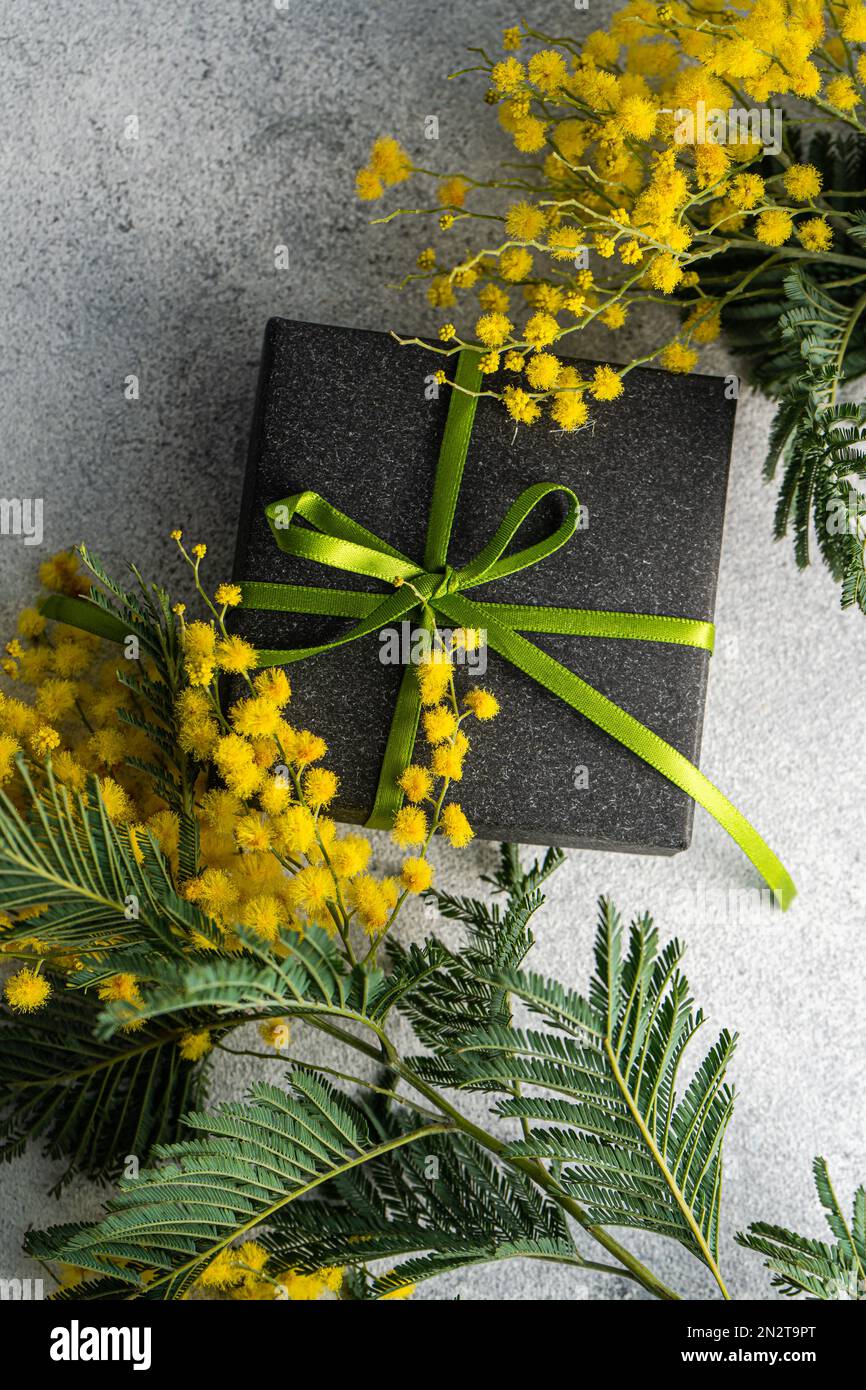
[0,531,499,1300]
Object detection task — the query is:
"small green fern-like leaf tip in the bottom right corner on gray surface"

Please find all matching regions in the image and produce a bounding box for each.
[737,1158,866,1300]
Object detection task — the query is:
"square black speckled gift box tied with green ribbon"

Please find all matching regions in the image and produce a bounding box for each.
[235,318,735,853]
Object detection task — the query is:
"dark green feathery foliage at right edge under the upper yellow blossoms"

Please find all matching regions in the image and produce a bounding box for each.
[702,128,866,613]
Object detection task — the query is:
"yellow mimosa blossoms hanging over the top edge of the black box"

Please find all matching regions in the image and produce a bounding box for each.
[357,0,866,431]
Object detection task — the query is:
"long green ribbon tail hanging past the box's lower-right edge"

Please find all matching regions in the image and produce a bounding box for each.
[438,595,796,910]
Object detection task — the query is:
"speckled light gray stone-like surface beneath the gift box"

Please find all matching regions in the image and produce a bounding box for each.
[0,0,866,1300]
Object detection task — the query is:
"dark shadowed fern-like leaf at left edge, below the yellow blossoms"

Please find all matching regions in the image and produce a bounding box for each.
[0,990,206,1191]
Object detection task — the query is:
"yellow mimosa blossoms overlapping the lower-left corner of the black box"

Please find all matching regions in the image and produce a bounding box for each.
[0,542,499,1000]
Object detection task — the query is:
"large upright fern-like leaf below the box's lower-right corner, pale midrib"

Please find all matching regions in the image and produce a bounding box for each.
[430,901,735,1280]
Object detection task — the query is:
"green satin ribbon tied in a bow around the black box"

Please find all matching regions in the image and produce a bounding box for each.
[240,352,796,908]
